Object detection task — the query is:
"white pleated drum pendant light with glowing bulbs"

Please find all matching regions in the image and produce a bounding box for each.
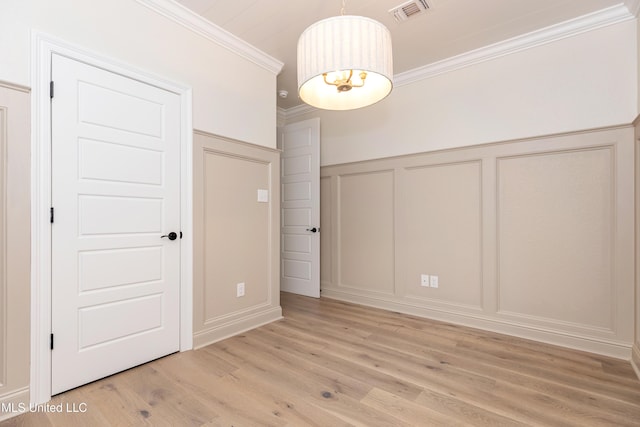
[298,0,393,110]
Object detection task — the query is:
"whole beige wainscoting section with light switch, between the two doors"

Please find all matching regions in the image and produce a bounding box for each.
[193,132,282,347]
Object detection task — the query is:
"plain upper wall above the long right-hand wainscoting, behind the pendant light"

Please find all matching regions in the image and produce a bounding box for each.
[287,20,639,166]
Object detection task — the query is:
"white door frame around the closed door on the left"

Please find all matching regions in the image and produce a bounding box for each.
[30,31,193,405]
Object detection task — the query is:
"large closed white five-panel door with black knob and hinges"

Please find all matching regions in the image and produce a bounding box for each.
[51,54,180,394]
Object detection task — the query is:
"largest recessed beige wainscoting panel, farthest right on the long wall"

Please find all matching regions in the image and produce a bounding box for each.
[497,146,615,331]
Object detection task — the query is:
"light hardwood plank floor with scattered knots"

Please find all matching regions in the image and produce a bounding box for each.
[5,293,640,427]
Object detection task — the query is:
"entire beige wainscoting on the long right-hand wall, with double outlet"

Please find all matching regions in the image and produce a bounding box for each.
[321,126,634,359]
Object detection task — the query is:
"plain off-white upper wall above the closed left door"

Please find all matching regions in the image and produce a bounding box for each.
[0,0,276,147]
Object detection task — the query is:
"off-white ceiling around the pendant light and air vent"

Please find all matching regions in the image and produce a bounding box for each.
[177,0,622,109]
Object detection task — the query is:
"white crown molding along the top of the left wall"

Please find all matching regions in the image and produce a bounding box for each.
[136,0,284,75]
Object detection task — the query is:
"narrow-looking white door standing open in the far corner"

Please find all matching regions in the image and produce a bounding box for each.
[280,119,320,298]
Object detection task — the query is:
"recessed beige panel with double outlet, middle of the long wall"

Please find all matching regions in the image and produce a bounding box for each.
[400,161,482,309]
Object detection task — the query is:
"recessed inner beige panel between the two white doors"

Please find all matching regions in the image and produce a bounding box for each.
[202,154,270,323]
